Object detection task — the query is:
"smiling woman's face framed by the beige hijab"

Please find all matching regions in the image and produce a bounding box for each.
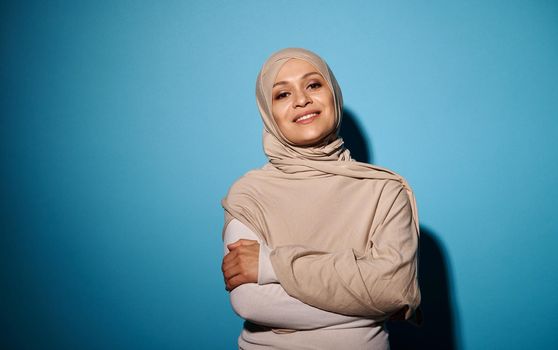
[271,59,335,146]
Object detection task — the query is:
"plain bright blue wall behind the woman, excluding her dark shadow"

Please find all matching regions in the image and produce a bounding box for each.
[0,1,558,349]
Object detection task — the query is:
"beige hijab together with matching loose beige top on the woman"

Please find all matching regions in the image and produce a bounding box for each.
[222,48,420,319]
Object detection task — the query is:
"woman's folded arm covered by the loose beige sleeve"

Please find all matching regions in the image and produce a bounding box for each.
[270,185,420,319]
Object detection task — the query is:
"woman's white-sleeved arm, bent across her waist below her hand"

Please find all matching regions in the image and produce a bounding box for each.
[224,219,374,330]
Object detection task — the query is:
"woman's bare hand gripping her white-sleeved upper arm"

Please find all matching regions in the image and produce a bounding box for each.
[221,239,260,292]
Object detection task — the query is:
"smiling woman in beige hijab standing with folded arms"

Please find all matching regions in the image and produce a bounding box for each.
[222,48,420,349]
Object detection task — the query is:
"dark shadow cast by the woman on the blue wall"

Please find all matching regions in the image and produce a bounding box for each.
[340,108,458,350]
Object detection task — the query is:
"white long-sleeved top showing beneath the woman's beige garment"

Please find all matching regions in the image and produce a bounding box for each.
[224,219,389,349]
